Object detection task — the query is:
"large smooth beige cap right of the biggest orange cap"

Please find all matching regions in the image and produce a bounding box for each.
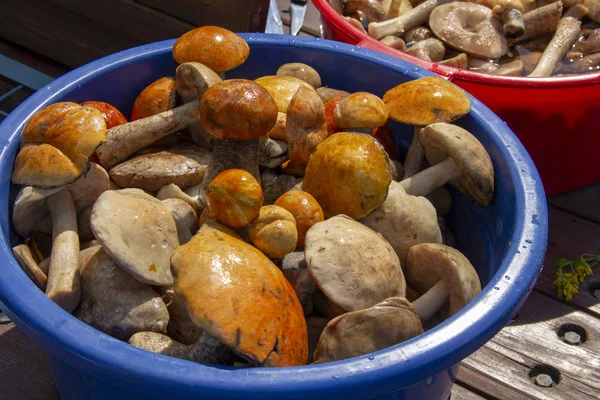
[304,215,406,311]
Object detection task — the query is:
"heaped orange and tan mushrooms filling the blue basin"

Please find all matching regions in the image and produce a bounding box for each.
[12,26,494,367]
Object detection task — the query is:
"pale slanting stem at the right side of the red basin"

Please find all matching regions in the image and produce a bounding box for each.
[529,17,581,77]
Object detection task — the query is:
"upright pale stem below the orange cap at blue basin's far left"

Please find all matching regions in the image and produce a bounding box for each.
[46,190,81,312]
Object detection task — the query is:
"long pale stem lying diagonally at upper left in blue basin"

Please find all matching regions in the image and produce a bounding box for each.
[96,101,198,169]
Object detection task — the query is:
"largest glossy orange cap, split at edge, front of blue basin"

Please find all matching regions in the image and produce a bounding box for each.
[171,220,308,367]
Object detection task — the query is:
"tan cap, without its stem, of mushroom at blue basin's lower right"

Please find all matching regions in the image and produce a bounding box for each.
[404,243,481,316]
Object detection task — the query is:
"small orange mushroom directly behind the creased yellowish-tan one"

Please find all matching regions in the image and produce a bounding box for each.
[275,190,325,249]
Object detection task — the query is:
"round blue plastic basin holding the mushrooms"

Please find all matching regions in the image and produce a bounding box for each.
[0,34,547,400]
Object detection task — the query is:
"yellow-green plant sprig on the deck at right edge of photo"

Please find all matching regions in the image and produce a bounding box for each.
[554,250,600,301]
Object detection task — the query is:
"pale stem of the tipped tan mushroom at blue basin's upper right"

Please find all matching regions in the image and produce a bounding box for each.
[400,157,462,196]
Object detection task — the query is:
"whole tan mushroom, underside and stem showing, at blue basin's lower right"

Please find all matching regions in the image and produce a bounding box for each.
[404,243,481,321]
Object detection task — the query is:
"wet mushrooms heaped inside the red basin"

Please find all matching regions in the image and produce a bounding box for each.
[330,0,600,77]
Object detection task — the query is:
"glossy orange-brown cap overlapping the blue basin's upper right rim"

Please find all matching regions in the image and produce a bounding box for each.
[383,76,471,126]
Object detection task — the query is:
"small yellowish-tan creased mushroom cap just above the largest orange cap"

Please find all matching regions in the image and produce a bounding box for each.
[248,205,298,258]
